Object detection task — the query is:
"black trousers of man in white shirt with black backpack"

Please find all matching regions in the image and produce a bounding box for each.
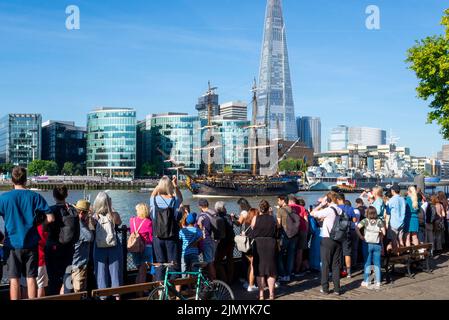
[320,238,343,292]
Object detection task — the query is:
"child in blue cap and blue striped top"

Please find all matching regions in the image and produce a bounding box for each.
[179,213,203,272]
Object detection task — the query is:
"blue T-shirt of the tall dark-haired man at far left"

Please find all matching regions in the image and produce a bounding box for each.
[0,190,51,249]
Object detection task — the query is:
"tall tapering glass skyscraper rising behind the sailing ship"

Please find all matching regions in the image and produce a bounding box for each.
[257,0,298,141]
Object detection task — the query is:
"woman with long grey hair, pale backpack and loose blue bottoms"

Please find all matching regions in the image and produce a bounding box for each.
[93,192,123,299]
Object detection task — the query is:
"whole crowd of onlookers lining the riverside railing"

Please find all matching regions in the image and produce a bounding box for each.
[0,167,449,300]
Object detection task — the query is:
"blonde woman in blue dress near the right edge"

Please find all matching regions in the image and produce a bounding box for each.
[404,187,421,247]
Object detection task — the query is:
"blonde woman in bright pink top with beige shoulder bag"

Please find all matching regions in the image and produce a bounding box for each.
[129,203,153,283]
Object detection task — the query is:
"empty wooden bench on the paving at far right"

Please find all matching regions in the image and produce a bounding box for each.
[385,243,433,282]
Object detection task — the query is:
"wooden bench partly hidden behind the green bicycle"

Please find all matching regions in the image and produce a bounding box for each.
[92,278,196,300]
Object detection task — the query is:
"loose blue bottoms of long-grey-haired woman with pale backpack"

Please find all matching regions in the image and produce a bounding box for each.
[94,244,123,289]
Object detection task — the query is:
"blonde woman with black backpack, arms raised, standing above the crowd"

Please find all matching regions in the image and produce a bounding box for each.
[150,176,182,281]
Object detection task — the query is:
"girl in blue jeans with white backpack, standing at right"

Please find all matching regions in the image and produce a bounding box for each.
[356,207,386,289]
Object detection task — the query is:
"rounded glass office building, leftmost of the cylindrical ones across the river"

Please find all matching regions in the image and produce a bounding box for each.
[87,108,137,180]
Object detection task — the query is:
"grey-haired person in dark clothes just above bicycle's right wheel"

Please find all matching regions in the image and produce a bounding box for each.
[215,201,235,284]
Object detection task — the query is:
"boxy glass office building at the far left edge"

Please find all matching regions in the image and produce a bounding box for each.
[0,114,42,167]
